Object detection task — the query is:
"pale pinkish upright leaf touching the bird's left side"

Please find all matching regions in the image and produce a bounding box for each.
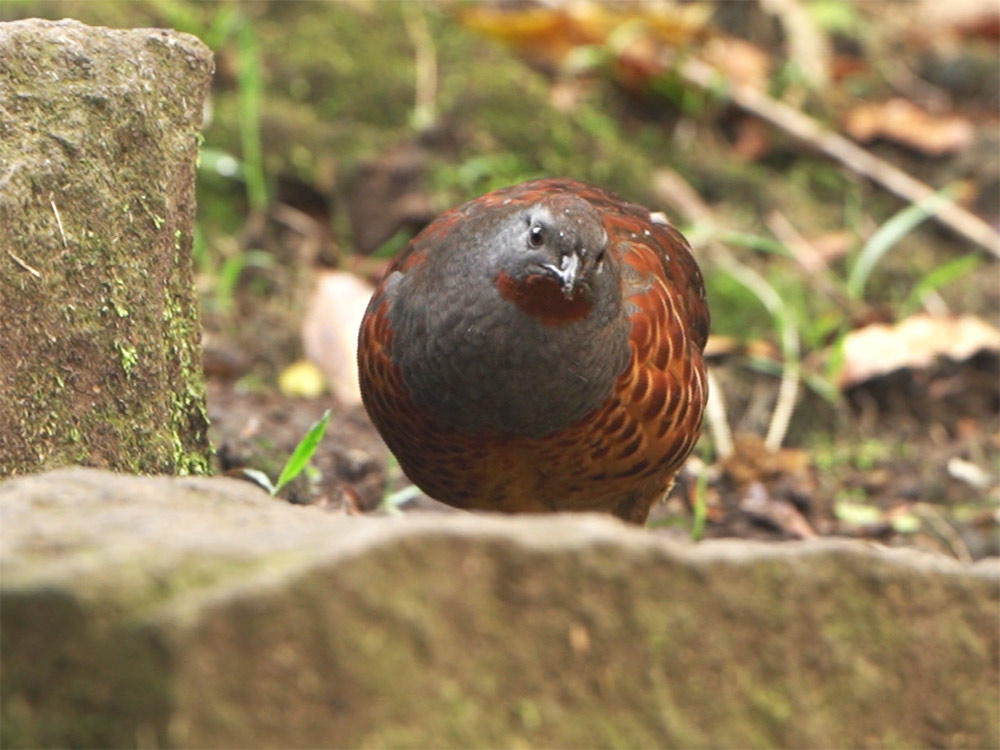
[302,271,374,405]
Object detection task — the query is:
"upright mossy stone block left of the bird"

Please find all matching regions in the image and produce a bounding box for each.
[0,20,213,476]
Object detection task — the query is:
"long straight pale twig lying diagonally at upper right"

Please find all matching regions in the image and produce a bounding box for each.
[678,58,1000,257]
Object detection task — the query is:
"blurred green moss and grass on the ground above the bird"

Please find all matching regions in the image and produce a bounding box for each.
[0,0,981,418]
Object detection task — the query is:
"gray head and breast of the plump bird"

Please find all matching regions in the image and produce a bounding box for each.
[386,195,628,437]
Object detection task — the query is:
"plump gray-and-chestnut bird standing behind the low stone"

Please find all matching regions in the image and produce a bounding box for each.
[358,178,709,525]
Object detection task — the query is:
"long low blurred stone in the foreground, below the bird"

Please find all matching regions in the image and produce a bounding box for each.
[0,469,1000,747]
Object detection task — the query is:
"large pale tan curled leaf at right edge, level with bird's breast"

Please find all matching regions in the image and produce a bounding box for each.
[840,314,1000,388]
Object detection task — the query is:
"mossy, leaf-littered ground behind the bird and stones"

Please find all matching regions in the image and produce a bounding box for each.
[9,0,1000,559]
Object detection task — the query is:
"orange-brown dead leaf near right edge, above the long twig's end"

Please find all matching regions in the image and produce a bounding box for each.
[844,98,975,156]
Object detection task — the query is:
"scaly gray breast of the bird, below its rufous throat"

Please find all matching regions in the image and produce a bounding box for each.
[390,279,629,437]
